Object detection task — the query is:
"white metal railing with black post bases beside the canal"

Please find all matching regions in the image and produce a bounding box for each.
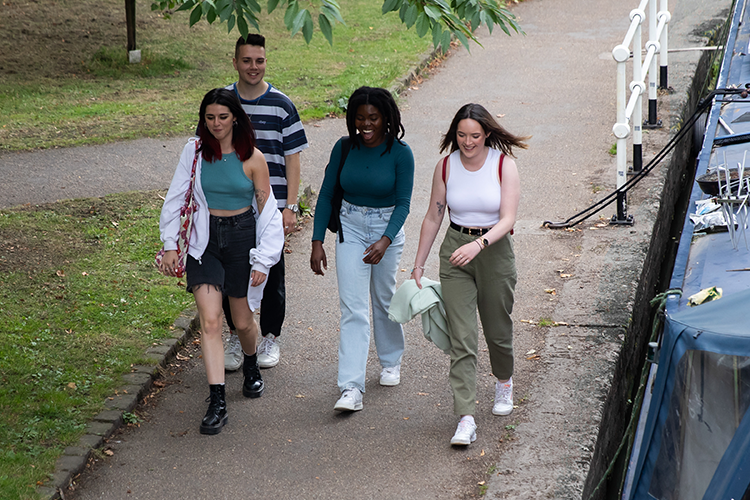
[612,0,671,224]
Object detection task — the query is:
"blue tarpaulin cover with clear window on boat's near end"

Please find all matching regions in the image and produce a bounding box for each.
[631,290,750,500]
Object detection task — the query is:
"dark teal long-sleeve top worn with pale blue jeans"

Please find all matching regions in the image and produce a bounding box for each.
[312,139,414,241]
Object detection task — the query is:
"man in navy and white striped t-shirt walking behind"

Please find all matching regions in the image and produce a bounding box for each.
[224,34,308,370]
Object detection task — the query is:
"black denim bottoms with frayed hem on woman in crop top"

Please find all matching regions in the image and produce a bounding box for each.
[185,208,255,297]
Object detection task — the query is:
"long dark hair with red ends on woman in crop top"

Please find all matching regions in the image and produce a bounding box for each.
[197,88,255,161]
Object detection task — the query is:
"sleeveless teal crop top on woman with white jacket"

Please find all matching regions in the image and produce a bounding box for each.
[201,153,255,210]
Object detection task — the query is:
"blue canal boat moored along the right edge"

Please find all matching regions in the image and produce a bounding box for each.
[622,0,750,500]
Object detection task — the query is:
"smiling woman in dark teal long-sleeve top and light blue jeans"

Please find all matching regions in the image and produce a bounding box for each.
[310,87,414,411]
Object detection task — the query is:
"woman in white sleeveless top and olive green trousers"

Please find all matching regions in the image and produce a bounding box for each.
[412,104,529,445]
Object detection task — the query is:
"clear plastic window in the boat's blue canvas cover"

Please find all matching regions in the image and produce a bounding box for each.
[649,351,750,500]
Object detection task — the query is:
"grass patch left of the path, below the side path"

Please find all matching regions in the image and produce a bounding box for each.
[0,192,192,498]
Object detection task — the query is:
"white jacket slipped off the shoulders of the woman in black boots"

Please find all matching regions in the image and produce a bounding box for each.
[159,137,284,311]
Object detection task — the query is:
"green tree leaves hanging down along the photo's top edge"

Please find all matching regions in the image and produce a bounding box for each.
[151,0,520,51]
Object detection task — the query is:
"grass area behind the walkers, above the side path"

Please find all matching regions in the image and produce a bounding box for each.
[0,0,430,151]
